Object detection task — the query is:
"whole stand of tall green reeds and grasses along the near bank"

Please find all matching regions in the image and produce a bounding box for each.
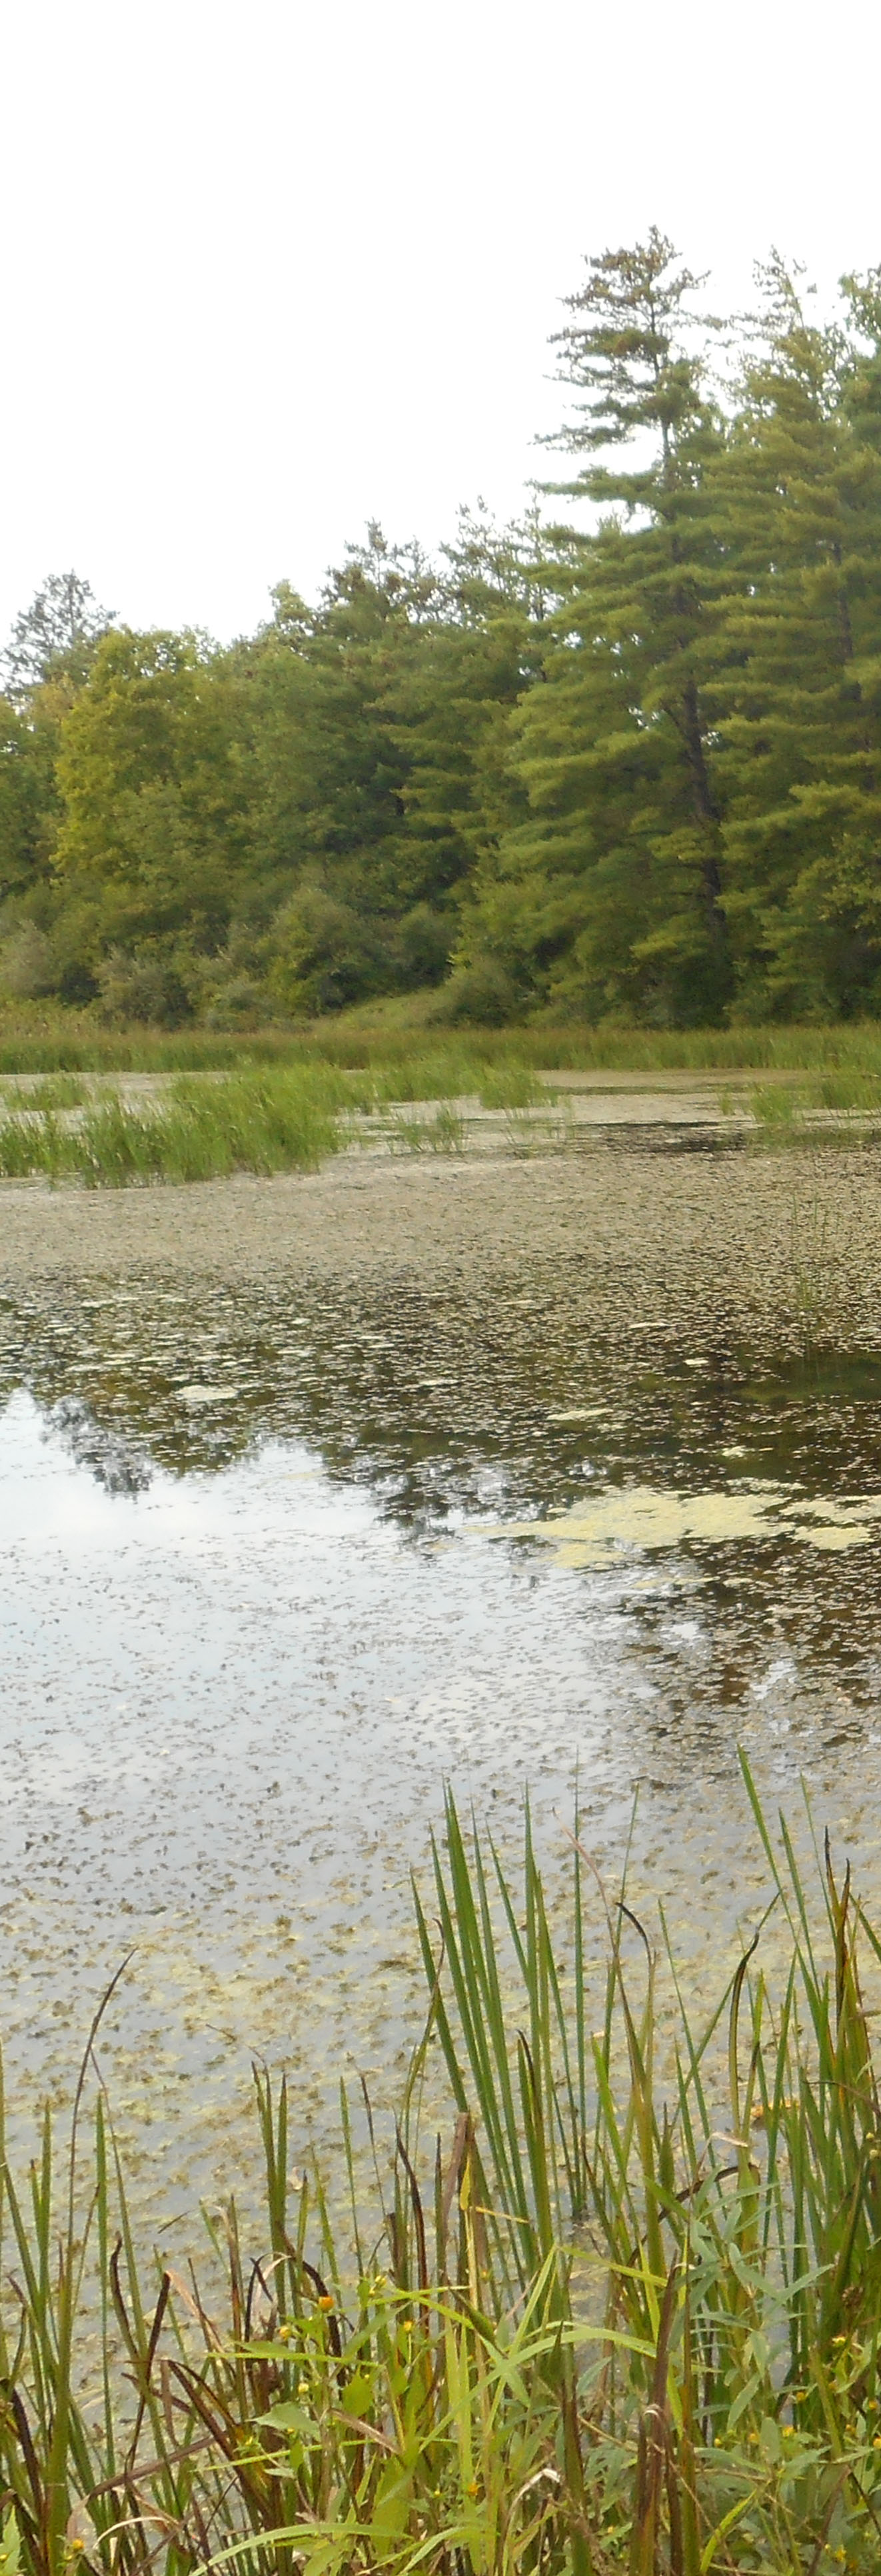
[0,1765,881,2576]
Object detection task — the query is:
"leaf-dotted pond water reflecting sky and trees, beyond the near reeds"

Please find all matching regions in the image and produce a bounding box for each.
[0,1236,881,2231]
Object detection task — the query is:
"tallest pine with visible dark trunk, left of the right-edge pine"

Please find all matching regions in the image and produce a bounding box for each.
[466,232,732,1020]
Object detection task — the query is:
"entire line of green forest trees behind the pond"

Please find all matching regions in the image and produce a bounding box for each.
[0,232,881,1028]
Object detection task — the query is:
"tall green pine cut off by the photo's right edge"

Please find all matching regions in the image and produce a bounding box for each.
[711,260,881,1017]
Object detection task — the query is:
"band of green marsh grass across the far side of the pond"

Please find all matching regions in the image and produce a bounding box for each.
[0,1046,881,1190]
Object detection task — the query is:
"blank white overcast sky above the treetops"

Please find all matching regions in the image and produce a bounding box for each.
[0,0,881,636]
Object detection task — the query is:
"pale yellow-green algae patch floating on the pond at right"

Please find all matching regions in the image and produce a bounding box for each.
[489,1479,881,1566]
